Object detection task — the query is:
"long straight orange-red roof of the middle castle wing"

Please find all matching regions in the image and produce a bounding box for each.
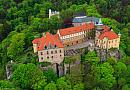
[59,23,95,36]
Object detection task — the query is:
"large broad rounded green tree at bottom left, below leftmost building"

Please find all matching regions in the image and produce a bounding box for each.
[12,63,46,89]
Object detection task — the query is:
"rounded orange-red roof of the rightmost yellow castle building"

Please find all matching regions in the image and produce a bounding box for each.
[99,31,118,40]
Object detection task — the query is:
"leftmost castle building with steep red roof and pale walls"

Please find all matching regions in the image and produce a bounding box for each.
[32,32,64,64]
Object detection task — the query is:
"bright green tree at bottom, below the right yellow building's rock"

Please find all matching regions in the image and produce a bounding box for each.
[95,62,115,89]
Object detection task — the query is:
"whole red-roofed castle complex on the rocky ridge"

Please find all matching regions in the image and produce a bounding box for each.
[32,16,121,64]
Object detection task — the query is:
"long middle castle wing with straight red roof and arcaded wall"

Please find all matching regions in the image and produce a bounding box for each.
[57,23,95,47]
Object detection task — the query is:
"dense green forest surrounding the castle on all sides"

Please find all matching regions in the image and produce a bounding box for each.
[0,0,130,90]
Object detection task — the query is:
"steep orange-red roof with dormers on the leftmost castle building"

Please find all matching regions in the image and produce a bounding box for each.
[32,32,63,50]
